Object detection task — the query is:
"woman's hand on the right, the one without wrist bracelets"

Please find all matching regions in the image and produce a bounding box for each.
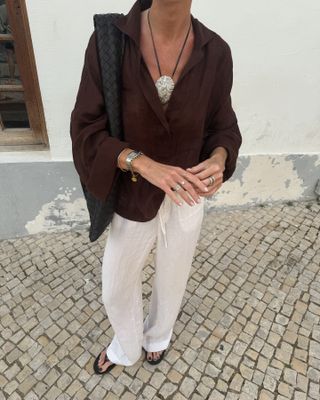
[187,154,225,197]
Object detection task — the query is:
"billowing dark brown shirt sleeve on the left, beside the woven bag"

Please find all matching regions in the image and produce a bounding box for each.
[70,31,130,201]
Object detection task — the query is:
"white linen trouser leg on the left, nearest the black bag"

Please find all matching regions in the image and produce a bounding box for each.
[102,213,156,365]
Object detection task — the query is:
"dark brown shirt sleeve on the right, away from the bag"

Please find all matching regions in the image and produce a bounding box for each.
[200,42,242,182]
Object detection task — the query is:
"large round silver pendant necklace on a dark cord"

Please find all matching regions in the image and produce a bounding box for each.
[147,9,192,104]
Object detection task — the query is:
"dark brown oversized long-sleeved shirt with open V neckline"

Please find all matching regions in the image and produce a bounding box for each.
[70,0,242,221]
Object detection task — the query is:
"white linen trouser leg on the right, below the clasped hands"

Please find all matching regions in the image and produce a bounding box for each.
[143,197,204,351]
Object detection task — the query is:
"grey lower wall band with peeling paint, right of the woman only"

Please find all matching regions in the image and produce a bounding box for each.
[206,154,320,208]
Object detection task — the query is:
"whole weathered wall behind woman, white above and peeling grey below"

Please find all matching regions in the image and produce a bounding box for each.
[0,0,320,238]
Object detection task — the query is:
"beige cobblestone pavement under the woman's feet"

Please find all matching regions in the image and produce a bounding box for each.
[0,201,320,400]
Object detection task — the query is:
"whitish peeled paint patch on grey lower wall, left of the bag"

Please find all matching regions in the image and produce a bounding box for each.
[25,187,89,234]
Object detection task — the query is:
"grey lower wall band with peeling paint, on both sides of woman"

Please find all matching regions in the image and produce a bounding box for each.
[0,153,320,238]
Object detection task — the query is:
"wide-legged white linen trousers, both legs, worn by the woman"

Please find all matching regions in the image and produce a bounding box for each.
[102,194,204,366]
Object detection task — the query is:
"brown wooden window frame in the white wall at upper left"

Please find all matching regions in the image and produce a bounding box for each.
[0,0,49,151]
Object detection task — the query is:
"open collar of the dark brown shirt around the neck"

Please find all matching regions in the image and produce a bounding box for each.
[114,0,215,48]
